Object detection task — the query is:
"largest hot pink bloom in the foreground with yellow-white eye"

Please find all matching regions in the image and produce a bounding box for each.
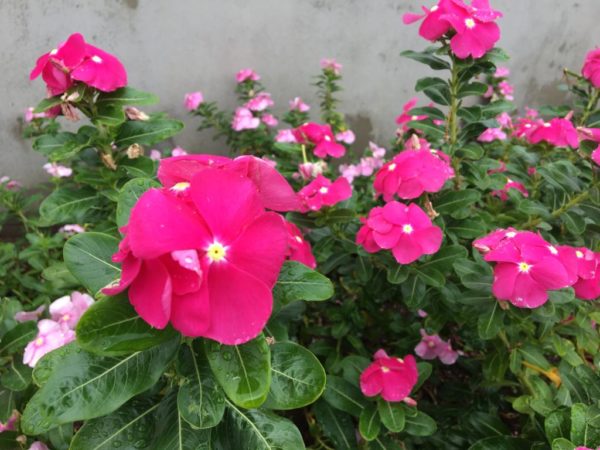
[104,168,288,345]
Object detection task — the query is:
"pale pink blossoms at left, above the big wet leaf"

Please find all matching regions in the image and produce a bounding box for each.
[21,292,94,367]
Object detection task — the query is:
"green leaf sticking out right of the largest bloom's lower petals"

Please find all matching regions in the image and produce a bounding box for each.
[273,261,333,305]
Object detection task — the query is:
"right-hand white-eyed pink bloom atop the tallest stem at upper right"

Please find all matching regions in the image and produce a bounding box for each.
[441,0,502,59]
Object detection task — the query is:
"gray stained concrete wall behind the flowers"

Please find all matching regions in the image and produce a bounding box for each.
[0,0,600,184]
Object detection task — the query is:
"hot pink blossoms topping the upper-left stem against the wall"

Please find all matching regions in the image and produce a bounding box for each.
[29,33,127,95]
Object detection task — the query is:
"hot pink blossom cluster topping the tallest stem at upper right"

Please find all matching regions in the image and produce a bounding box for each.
[403,0,502,59]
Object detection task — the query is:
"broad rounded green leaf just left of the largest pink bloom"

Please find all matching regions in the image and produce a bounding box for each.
[63,233,121,295]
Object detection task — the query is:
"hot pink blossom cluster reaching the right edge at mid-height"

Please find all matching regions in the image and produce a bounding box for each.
[473,228,600,308]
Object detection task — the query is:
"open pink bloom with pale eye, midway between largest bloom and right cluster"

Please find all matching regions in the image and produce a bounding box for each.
[356,201,443,264]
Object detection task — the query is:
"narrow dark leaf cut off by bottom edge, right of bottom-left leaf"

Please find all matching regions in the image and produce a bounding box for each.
[152,392,214,450]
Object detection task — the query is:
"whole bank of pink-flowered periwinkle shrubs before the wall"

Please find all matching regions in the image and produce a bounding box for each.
[0,0,600,450]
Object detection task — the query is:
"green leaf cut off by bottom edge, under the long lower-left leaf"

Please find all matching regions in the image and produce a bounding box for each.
[69,398,159,450]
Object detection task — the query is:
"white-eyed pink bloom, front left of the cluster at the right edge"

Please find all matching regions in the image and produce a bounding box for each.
[484,231,573,308]
